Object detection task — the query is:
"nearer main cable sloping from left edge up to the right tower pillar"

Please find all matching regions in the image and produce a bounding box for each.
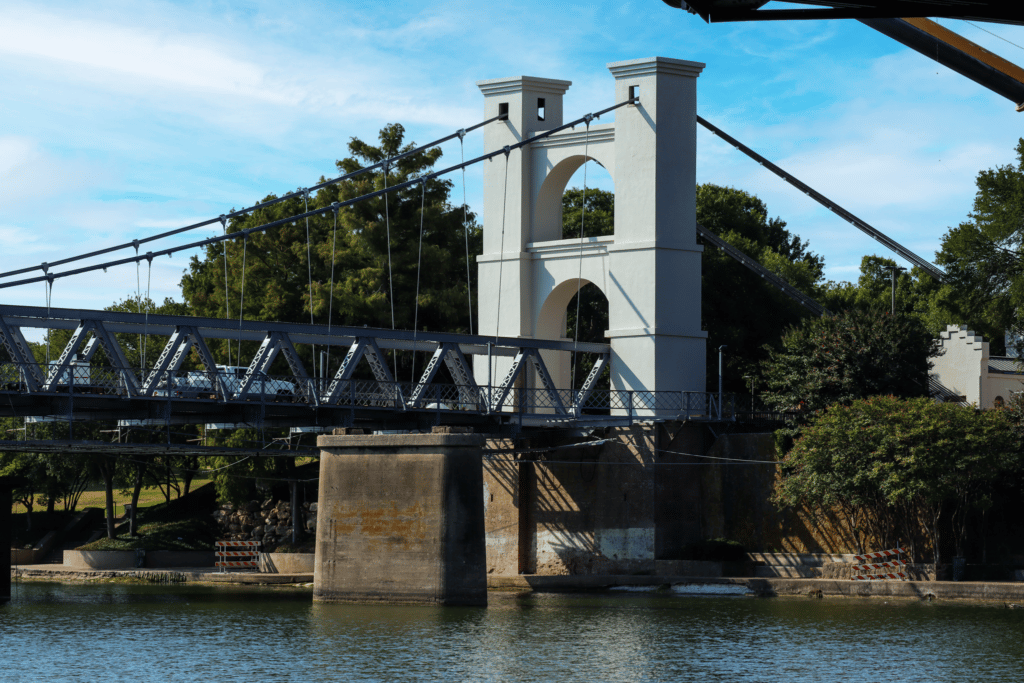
[0,98,639,289]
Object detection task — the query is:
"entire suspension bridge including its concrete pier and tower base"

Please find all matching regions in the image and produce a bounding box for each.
[0,57,958,605]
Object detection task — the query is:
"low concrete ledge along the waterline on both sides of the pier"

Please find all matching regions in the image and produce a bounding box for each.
[10,564,1024,605]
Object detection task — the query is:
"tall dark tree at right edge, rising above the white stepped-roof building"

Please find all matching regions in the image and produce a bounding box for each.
[936,138,1024,351]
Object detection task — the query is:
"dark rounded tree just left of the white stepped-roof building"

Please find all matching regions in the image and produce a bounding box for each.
[760,309,939,416]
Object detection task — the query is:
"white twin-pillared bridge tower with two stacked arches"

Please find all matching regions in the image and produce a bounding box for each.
[475,57,708,405]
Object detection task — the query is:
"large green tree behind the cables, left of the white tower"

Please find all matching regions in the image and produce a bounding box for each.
[181,124,482,377]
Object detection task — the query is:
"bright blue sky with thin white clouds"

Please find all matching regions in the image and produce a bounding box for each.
[0,0,1024,307]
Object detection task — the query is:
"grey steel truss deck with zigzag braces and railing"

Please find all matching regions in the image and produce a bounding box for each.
[0,305,735,429]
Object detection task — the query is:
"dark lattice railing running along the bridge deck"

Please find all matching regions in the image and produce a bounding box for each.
[0,362,750,421]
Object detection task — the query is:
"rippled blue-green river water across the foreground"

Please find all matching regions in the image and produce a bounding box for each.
[0,583,1024,683]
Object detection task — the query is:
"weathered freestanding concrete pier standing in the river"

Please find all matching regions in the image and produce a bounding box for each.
[313,434,487,606]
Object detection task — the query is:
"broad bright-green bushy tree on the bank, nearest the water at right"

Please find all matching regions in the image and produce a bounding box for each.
[775,396,1020,565]
